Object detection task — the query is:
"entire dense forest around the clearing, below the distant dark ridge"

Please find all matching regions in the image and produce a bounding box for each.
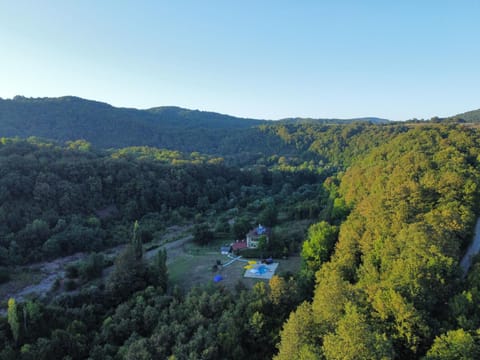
[0,109,480,359]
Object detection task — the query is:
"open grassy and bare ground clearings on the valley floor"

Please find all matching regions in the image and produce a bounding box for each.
[0,226,301,314]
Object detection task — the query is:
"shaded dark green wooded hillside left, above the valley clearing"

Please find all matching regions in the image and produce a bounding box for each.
[0,138,325,267]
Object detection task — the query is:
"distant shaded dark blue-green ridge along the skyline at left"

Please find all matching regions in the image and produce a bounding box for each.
[0,96,387,154]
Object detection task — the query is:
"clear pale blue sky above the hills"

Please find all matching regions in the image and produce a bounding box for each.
[0,0,480,120]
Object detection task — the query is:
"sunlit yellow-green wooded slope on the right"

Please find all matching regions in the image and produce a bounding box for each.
[276,126,480,359]
